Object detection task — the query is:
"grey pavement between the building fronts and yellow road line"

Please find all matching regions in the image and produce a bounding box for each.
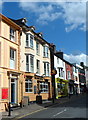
[0,95,84,120]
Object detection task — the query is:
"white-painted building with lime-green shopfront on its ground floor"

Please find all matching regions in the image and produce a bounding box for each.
[54,55,68,98]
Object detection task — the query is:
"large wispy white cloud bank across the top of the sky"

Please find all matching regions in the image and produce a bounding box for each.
[19,0,86,32]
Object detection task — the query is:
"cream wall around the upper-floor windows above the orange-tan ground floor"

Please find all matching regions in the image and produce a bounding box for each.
[20,31,51,75]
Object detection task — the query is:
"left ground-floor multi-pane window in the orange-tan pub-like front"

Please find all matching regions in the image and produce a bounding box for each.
[25,77,33,93]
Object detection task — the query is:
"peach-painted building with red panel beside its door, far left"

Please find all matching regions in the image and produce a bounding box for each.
[0,14,21,110]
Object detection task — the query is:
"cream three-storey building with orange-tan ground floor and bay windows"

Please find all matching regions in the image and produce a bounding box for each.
[11,18,52,101]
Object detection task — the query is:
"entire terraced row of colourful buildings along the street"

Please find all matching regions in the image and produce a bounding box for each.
[0,14,86,109]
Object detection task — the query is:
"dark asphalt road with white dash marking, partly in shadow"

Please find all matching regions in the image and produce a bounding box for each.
[18,95,88,120]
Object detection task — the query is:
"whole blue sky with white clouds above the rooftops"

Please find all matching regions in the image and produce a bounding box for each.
[0,0,86,63]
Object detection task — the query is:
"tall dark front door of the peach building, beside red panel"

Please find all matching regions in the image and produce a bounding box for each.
[11,78,17,103]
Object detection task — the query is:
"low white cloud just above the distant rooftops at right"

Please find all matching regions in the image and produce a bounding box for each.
[64,53,88,65]
